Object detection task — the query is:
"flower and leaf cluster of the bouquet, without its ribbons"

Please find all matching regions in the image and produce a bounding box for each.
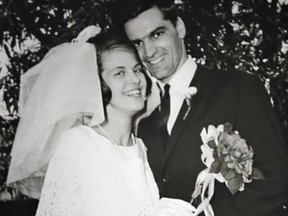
[204,122,264,195]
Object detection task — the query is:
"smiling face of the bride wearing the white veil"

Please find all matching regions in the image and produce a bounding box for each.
[101,47,147,114]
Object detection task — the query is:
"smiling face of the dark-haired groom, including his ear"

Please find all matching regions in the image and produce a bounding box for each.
[124,7,187,83]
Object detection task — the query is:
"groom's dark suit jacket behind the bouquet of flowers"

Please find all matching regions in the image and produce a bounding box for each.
[138,66,288,216]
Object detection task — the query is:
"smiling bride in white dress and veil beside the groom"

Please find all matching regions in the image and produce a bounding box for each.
[7,26,195,216]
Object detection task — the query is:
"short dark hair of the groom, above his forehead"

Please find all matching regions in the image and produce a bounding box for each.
[111,0,178,32]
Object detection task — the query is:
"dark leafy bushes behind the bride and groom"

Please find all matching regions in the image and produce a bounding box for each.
[0,0,288,199]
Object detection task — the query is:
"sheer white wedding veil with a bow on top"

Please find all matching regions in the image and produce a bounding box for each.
[7,26,105,198]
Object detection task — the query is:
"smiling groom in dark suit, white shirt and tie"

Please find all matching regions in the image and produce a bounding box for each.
[114,0,288,216]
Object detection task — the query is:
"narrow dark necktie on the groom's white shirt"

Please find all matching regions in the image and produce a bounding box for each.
[159,84,170,149]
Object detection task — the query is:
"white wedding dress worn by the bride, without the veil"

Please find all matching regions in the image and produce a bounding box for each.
[36,126,159,216]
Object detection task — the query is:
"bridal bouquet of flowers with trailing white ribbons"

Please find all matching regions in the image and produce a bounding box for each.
[191,123,264,216]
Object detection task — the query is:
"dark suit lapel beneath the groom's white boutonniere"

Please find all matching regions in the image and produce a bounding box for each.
[162,66,204,168]
